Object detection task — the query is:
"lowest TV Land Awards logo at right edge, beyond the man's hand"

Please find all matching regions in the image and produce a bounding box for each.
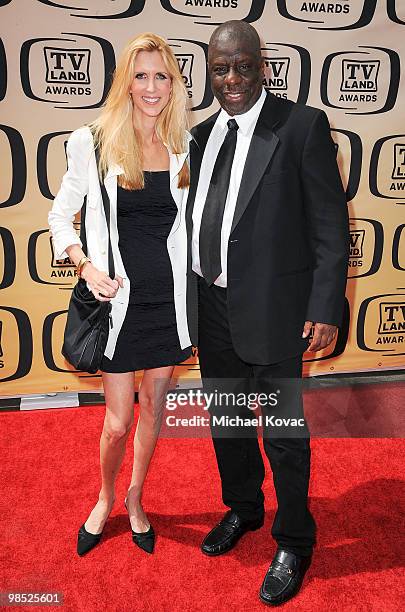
[357,293,405,357]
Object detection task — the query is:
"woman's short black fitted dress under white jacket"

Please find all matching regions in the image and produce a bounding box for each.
[100,170,191,372]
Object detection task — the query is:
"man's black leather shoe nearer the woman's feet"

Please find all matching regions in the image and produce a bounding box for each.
[201,510,264,557]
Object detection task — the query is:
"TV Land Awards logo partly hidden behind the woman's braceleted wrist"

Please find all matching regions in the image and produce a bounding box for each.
[28,228,80,289]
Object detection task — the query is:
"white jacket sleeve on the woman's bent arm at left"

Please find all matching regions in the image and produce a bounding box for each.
[48,127,94,259]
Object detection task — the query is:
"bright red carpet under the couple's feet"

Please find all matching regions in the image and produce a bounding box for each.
[0,406,405,612]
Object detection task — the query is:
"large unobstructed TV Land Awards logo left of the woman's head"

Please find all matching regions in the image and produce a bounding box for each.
[20,32,115,109]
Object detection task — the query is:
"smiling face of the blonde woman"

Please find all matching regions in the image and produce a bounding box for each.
[129,51,172,117]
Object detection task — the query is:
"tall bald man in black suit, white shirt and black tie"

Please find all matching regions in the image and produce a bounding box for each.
[186,21,349,605]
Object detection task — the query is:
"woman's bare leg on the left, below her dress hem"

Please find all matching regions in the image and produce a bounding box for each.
[85,372,135,533]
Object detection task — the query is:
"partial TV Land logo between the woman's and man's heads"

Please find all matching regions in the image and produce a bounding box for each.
[168,38,214,110]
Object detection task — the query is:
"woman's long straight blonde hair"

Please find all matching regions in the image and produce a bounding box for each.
[89,32,190,189]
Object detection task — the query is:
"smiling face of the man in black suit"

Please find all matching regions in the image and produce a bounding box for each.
[208,37,264,115]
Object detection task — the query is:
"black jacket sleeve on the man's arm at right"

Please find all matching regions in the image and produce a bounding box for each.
[301,111,349,326]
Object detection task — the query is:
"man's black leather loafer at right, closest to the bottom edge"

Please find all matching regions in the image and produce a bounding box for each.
[259,548,312,606]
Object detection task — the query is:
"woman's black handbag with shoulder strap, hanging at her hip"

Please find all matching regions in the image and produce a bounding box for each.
[62,142,115,374]
